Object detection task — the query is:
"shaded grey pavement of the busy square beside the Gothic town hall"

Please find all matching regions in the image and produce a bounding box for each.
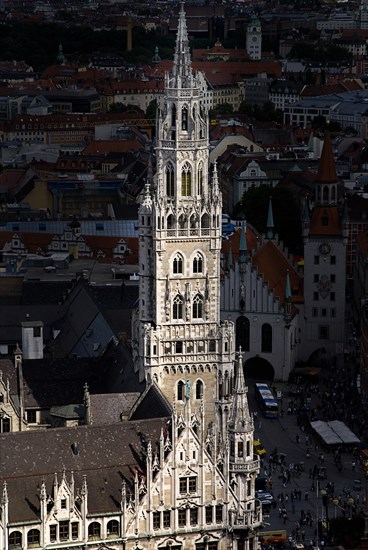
[248,381,365,545]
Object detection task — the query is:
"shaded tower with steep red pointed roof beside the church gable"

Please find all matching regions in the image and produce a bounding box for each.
[302,134,348,360]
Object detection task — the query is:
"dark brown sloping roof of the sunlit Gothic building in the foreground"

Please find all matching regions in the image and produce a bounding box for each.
[0,418,169,523]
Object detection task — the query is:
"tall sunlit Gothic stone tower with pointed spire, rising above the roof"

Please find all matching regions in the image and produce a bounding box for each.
[133,2,235,435]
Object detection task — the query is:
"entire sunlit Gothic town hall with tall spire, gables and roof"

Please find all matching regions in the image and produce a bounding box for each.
[0,7,262,550]
